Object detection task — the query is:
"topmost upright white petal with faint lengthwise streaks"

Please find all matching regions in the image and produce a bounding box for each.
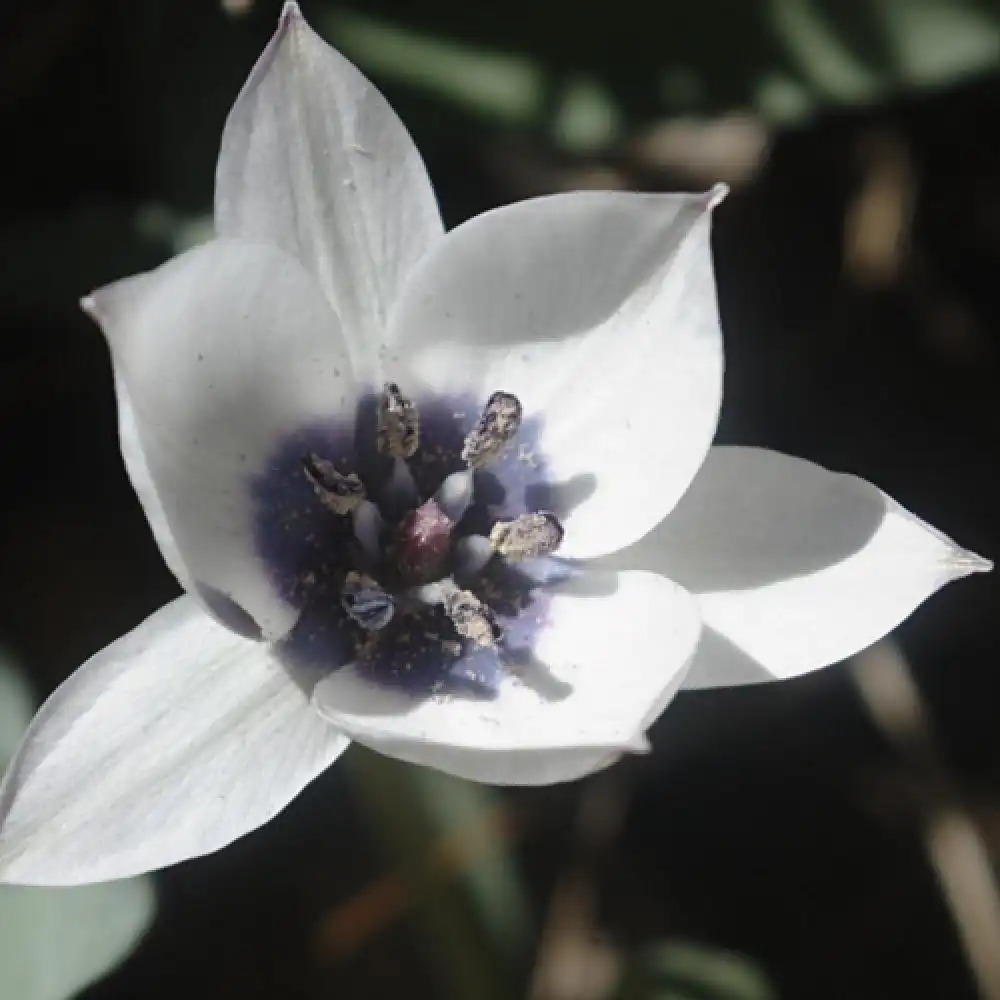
[215,3,443,374]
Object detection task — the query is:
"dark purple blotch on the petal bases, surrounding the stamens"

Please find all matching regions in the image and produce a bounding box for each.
[258,386,587,698]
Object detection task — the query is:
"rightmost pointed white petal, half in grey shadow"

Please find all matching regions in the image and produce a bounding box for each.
[613,448,990,687]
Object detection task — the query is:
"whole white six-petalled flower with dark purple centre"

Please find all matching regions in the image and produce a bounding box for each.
[0,4,988,883]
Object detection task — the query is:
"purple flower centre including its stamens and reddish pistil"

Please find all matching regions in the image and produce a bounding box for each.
[255,383,565,695]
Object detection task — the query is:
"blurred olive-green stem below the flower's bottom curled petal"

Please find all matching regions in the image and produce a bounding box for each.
[345,746,528,1000]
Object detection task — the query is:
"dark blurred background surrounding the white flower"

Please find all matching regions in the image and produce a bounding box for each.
[0,0,1000,1000]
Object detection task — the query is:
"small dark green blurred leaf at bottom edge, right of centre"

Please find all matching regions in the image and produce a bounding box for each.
[613,941,777,1000]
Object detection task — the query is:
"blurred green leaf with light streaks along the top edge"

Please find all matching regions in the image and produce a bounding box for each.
[317,0,1000,137]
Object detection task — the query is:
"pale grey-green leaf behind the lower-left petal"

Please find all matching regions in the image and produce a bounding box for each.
[0,658,155,1000]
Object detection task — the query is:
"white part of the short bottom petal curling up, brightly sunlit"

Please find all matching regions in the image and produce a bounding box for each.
[313,572,700,785]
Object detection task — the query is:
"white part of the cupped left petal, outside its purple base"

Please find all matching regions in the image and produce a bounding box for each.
[84,240,356,635]
